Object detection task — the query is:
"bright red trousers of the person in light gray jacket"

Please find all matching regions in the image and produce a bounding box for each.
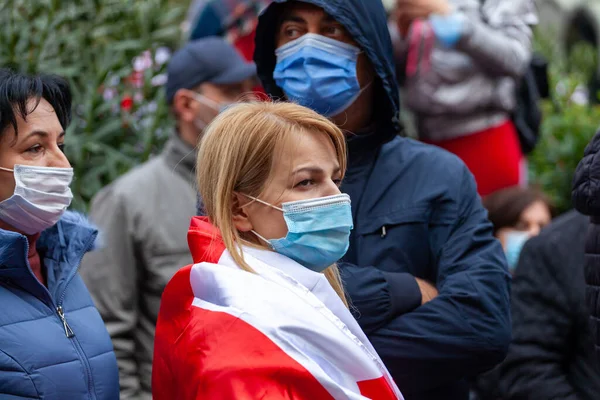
[428,121,527,196]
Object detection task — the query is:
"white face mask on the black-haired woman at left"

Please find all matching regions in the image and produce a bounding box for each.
[0,165,73,235]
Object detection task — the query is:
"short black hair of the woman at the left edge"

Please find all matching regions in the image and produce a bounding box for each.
[0,68,71,136]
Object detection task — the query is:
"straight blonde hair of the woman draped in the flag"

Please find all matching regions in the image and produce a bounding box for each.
[197,102,348,306]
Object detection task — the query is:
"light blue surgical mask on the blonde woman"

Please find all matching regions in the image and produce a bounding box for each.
[248,194,354,272]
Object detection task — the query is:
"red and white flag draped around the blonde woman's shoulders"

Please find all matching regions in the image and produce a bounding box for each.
[152,218,402,400]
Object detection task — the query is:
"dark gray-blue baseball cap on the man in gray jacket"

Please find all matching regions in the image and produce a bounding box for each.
[166,37,256,104]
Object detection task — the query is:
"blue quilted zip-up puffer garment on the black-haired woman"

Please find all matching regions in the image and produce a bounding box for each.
[0,212,119,400]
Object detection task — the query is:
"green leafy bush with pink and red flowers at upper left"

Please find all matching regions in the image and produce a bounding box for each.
[0,0,184,211]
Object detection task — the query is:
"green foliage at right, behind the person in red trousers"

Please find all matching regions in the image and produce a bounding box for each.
[529,36,600,216]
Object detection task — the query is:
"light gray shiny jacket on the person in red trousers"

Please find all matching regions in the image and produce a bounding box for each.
[390,0,537,141]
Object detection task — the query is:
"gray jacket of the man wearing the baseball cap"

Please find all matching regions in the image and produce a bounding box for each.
[81,135,196,399]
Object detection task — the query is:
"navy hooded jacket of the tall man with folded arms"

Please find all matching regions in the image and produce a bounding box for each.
[255,0,510,400]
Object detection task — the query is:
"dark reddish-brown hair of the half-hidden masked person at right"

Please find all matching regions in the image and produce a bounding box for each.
[483,186,554,233]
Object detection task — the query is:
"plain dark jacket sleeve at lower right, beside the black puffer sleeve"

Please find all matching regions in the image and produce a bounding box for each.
[500,233,578,400]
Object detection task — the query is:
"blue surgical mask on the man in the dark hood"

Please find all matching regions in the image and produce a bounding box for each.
[273,33,369,117]
